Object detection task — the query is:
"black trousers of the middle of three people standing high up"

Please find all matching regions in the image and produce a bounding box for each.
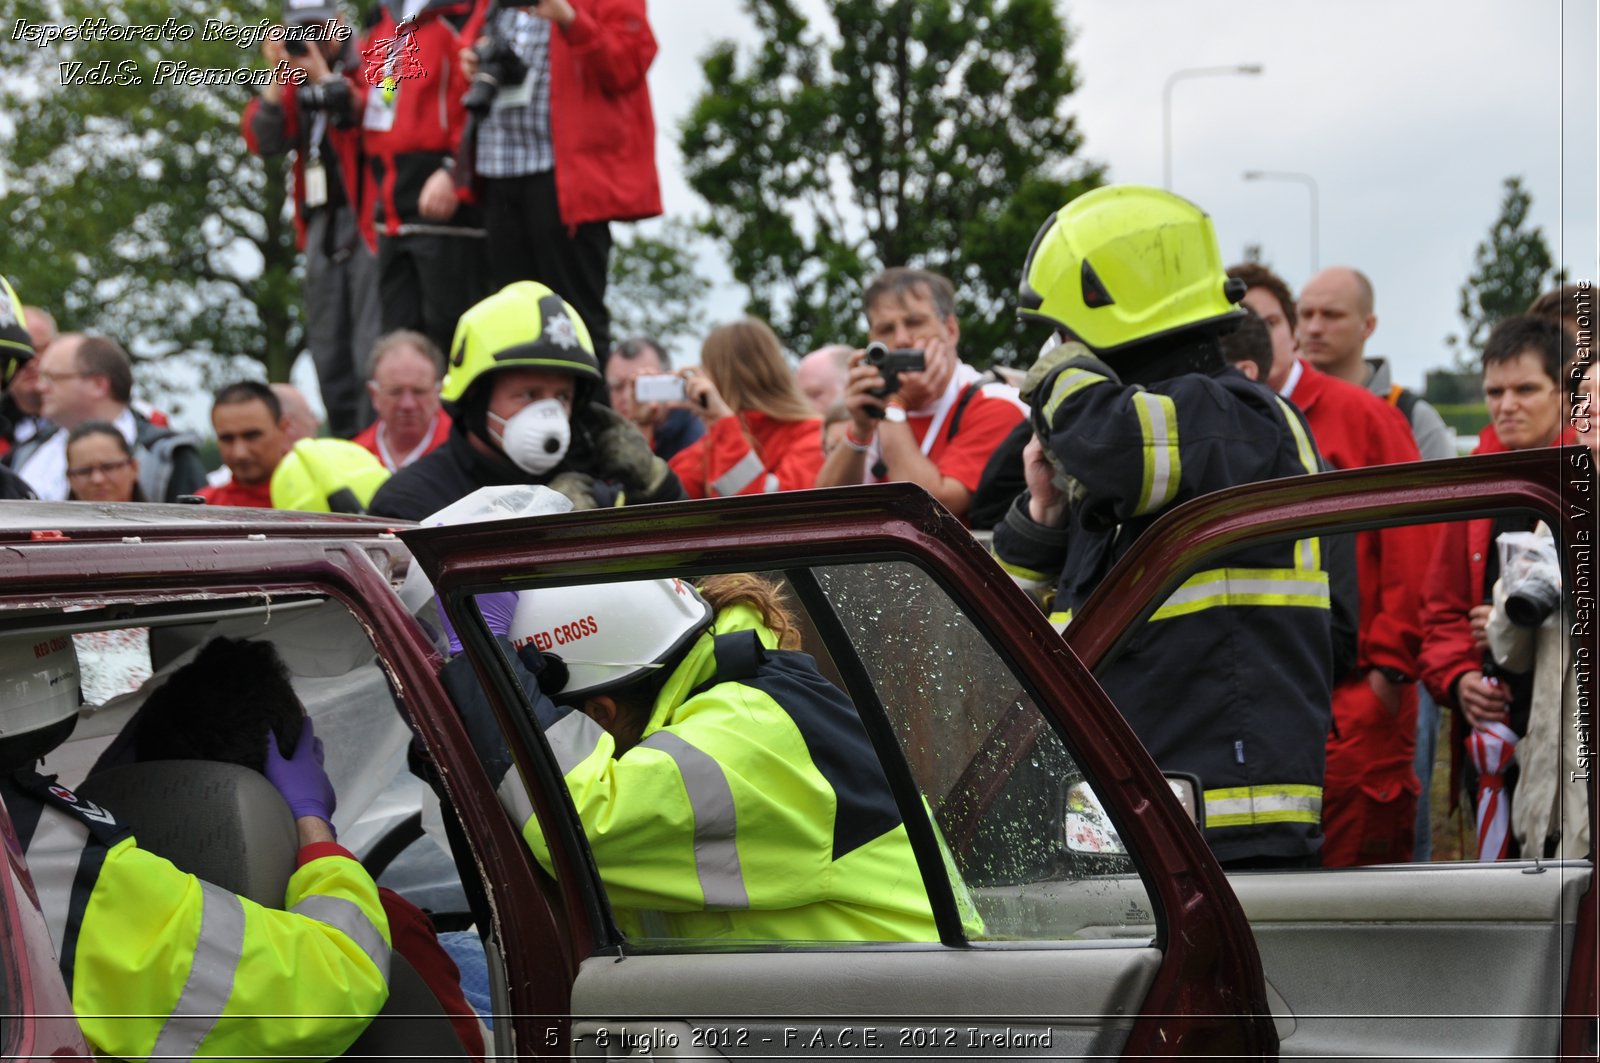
[378,232,490,357]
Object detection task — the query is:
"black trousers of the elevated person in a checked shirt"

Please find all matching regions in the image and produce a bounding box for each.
[483,171,611,363]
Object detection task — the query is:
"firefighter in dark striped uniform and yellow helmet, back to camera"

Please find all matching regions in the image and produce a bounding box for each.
[994,186,1333,866]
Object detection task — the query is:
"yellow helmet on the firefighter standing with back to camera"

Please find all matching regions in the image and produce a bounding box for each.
[1018,184,1245,352]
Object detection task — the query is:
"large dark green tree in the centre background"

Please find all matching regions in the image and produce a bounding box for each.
[680,0,1102,365]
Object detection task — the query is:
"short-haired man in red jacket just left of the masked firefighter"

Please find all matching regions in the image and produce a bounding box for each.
[350,328,450,472]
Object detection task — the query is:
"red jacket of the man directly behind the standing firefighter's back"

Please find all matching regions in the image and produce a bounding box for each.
[1290,360,1435,679]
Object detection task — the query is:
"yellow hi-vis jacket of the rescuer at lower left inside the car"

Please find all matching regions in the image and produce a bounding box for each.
[0,773,390,1060]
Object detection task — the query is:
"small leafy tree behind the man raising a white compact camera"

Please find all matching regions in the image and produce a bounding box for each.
[606,218,710,347]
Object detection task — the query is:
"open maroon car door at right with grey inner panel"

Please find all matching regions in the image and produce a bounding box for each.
[1066,448,1597,1060]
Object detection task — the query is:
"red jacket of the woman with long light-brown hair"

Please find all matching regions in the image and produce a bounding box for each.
[667,410,822,498]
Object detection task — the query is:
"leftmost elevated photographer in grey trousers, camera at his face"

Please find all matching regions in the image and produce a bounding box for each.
[242,0,379,435]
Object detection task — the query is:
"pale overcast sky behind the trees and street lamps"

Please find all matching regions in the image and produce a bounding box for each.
[640,0,1600,384]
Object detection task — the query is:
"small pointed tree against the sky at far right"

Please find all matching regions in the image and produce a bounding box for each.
[1445,178,1566,370]
